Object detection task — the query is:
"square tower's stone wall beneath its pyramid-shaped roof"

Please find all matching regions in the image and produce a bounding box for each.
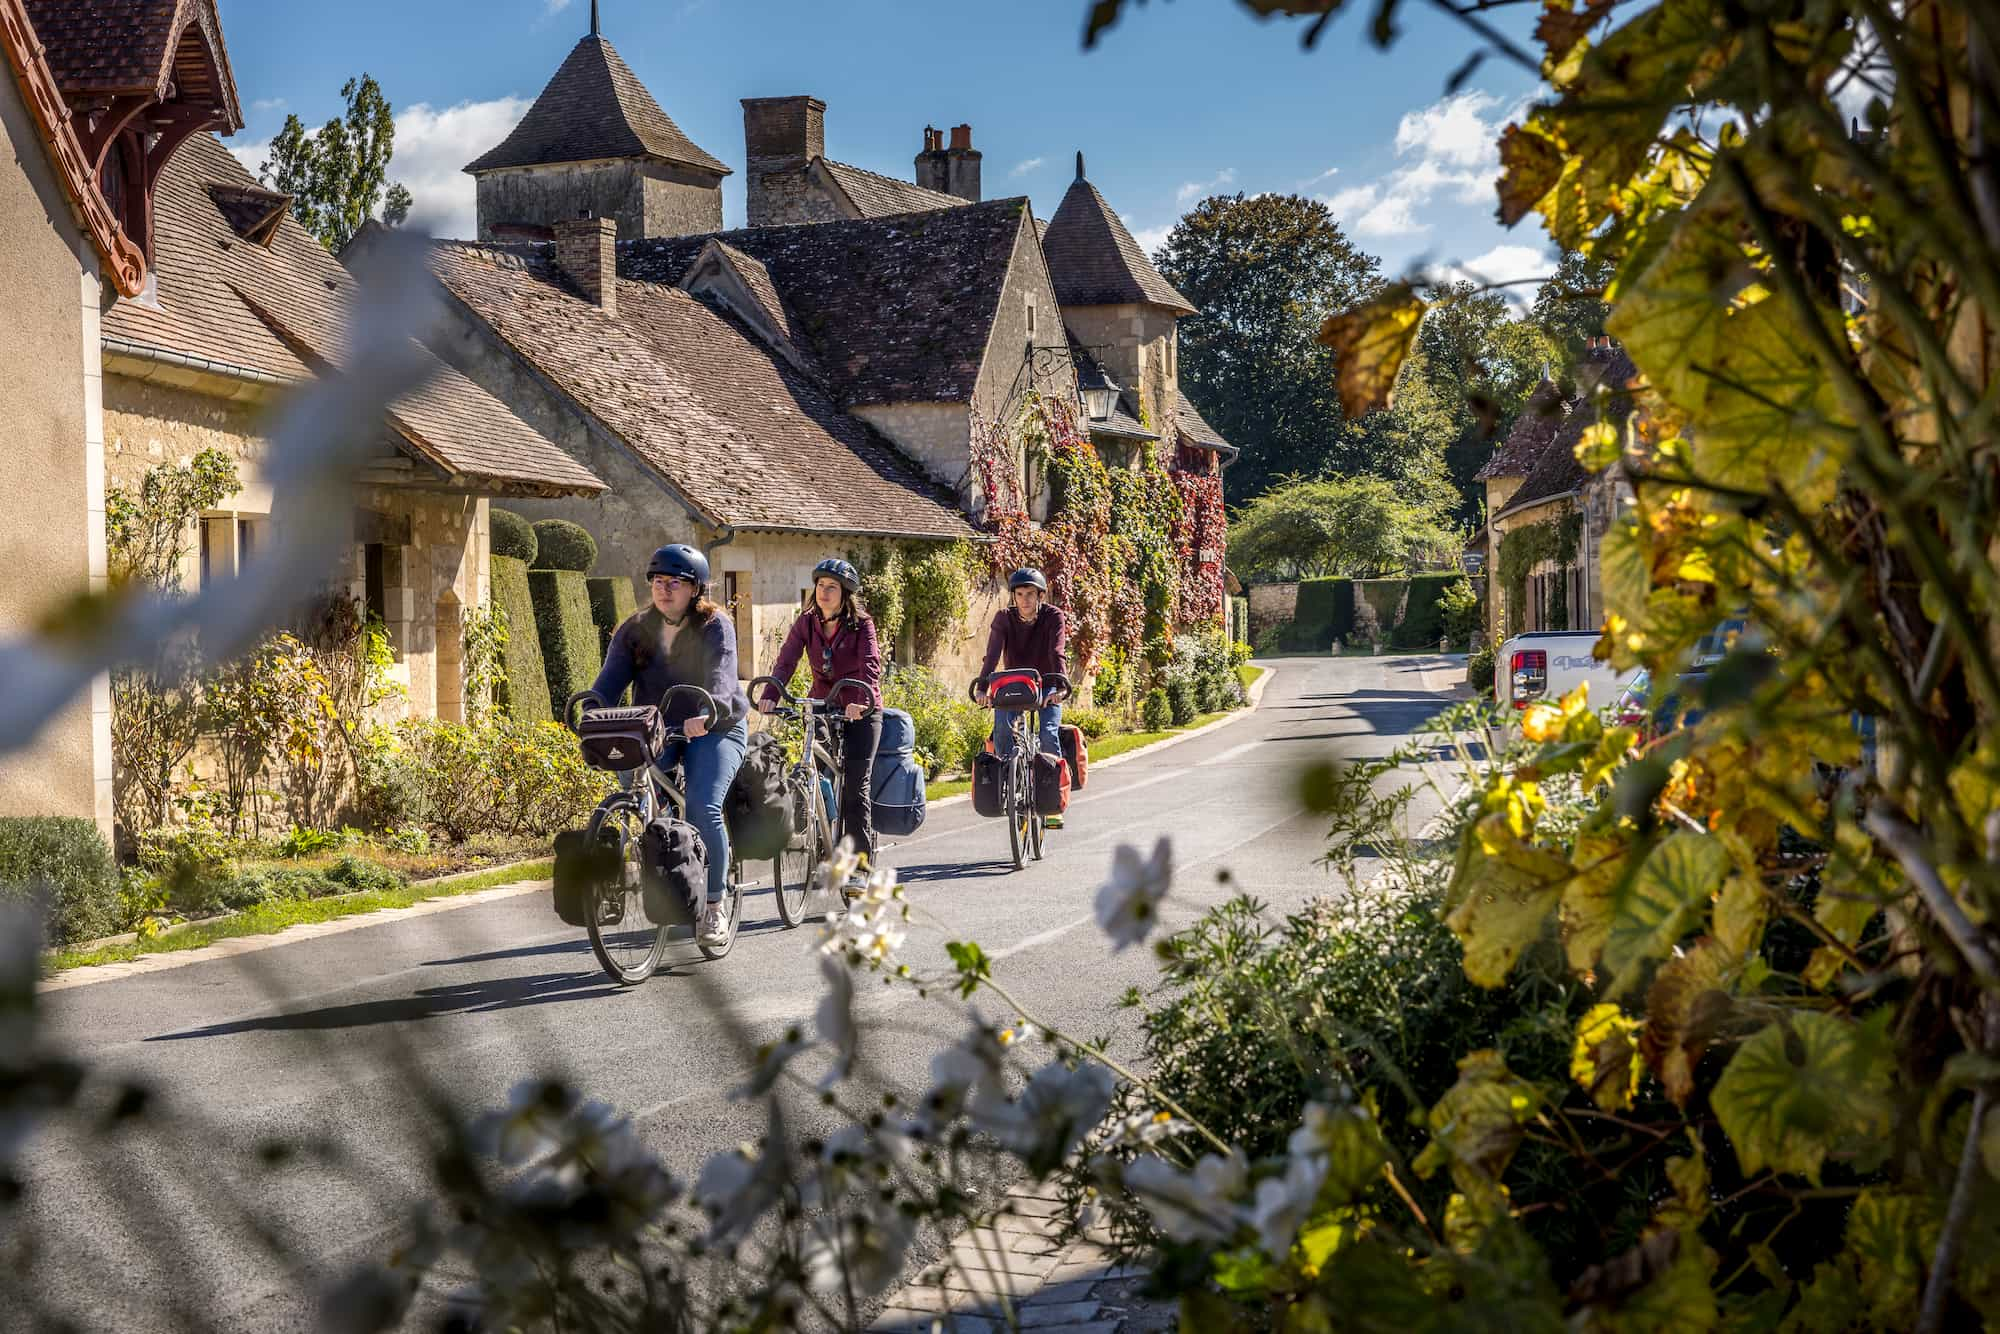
[478,158,722,240]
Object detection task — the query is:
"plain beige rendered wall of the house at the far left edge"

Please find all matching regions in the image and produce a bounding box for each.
[0,78,112,838]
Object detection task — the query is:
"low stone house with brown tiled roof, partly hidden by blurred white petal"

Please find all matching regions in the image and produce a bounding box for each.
[104,134,604,720]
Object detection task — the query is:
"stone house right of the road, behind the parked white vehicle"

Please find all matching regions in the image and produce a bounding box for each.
[1476,338,1638,642]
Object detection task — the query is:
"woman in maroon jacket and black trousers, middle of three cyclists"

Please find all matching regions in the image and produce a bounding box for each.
[756,558,882,886]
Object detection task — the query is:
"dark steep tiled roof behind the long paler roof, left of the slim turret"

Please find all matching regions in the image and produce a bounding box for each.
[618,198,1028,406]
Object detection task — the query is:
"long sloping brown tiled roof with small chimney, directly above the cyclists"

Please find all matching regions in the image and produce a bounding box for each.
[432,240,972,538]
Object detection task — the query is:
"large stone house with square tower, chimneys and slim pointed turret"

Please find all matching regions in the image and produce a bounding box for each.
[432,16,1232,672]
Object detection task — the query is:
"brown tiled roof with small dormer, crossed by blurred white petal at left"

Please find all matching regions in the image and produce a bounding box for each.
[102,134,604,494]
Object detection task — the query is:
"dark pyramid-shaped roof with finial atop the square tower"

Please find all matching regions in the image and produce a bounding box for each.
[466,34,730,176]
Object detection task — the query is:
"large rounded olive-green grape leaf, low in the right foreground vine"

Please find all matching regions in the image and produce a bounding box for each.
[1708,1010,1894,1184]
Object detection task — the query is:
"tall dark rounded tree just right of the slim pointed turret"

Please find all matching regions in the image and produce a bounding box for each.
[1156,194,1382,498]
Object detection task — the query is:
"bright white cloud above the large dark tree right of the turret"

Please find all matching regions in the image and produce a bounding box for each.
[1326,90,1522,240]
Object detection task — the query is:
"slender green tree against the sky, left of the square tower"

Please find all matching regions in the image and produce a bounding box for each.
[258,74,414,250]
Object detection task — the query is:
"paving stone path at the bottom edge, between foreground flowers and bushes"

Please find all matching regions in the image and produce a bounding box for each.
[872,1184,1174,1334]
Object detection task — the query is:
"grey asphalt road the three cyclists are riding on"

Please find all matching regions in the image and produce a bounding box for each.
[19,658,1464,1330]
